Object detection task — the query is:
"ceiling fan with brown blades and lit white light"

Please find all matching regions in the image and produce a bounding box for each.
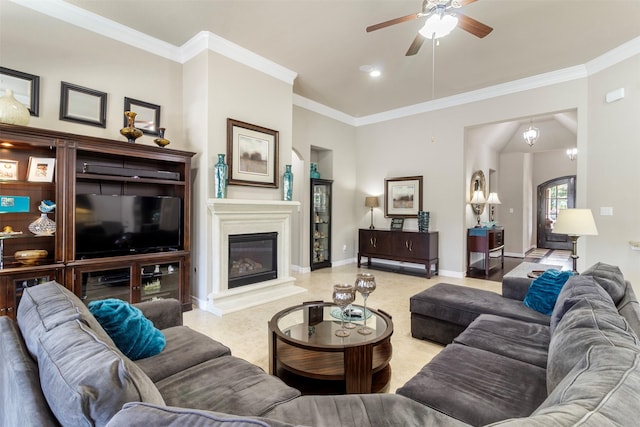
[367,0,493,56]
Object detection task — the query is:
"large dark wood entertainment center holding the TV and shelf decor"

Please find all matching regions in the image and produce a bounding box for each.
[0,124,195,315]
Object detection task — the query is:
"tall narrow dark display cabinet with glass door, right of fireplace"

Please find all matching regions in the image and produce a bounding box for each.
[310,178,333,270]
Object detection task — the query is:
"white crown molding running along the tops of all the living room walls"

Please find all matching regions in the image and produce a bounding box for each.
[10,0,640,127]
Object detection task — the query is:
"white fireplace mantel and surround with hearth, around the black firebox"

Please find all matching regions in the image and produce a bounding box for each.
[206,199,306,316]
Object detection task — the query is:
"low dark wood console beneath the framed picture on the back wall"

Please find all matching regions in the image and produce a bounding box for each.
[358,228,438,279]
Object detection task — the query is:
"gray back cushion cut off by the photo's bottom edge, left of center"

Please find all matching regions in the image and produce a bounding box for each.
[107,402,292,427]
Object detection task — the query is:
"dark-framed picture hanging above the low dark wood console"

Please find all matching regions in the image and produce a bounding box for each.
[384,176,422,218]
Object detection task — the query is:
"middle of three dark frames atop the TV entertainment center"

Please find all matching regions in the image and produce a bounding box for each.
[60,82,107,128]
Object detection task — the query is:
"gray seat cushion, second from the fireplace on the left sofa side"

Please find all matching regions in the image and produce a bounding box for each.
[156,356,300,416]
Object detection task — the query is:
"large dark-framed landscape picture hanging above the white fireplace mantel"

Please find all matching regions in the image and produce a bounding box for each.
[227,119,279,188]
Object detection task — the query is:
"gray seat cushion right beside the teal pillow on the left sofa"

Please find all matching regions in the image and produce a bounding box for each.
[135,326,231,383]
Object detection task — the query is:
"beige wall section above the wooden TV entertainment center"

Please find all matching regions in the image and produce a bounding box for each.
[0,1,185,149]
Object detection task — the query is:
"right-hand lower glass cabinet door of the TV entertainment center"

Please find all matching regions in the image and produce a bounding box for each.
[140,262,182,301]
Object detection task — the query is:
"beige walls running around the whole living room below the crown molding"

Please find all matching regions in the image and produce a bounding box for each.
[0,2,640,298]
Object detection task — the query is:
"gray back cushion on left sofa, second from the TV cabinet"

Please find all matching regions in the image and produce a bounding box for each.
[38,320,164,426]
